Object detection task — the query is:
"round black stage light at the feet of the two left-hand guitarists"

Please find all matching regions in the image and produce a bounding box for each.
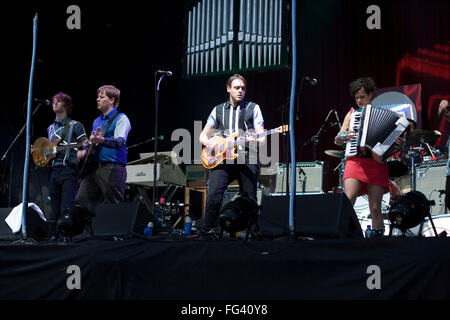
[57,205,94,238]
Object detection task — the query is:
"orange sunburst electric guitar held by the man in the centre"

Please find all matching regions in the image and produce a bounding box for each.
[202,125,289,169]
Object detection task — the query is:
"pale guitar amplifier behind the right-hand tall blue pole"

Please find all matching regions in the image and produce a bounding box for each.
[270,161,328,195]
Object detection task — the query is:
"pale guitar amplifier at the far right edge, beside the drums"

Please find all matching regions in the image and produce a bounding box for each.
[415,160,447,215]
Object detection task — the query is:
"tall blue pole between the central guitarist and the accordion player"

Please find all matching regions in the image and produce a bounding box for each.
[286,0,297,235]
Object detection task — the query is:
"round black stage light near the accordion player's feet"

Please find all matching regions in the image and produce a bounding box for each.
[388,191,430,234]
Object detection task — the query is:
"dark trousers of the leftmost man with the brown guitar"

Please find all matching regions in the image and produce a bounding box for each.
[49,166,78,222]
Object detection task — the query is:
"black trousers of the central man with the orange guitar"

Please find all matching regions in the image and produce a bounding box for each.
[205,164,259,228]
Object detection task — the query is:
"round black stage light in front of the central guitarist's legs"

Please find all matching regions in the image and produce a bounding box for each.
[219,197,259,234]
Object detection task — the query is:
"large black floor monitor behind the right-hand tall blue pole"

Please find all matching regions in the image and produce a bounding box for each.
[258,193,363,239]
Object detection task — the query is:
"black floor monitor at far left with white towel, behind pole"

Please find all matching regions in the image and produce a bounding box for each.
[0,208,49,240]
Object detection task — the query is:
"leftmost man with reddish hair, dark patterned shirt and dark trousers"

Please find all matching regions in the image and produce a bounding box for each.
[47,92,87,240]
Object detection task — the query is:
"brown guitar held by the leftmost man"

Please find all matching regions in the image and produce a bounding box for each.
[31,137,83,168]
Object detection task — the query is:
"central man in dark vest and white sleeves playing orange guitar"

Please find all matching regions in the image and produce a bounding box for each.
[199,74,265,231]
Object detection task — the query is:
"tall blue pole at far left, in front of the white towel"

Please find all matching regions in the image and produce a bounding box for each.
[22,13,38,239]
